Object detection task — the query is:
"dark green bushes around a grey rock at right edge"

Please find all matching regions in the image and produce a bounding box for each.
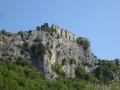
[94,60,120,83]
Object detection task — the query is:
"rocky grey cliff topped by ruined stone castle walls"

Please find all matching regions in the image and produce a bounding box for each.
[0,23,97,79]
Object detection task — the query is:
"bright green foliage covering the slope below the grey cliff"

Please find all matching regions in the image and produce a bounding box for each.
[0,57,120,90]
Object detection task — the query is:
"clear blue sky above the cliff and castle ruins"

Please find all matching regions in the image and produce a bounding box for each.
[0,0,120,60]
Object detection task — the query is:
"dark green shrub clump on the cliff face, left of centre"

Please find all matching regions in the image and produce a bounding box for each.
[18,39,52,57]
